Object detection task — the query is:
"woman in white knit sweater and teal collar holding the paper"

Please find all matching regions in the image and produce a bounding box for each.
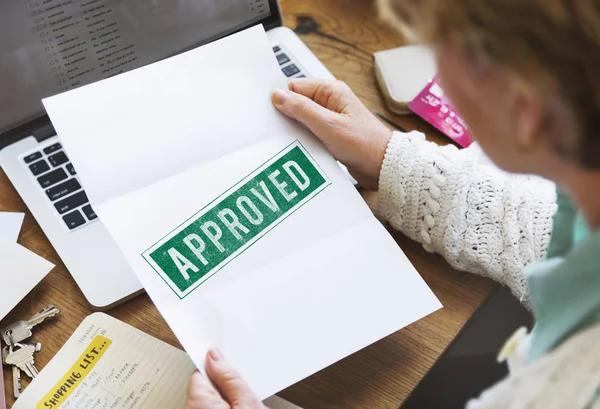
[183,0,600,409]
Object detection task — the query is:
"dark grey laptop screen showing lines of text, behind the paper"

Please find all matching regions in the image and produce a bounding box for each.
[0,0,277,133]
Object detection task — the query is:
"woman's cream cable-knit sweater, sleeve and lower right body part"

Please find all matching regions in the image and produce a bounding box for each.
[378,132,600,409]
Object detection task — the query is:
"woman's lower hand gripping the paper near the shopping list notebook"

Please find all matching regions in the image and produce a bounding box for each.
[185,349,267,409]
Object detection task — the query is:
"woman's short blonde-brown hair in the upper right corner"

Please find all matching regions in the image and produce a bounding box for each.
[379,0,600,169]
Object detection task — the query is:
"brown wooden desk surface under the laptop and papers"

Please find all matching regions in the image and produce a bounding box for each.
[0,0,496,409]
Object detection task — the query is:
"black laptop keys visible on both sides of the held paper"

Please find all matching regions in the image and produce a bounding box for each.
[23,46,306,230]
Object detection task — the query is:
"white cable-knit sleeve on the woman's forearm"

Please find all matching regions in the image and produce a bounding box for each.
[378,132,556,303]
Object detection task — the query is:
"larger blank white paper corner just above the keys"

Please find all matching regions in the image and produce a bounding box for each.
[0,237,54,320]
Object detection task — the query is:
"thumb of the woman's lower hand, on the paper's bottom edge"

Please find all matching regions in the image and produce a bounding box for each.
[206,349,264,408]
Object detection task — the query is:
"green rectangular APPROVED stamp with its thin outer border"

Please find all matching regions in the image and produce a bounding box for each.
[142,141,331,299]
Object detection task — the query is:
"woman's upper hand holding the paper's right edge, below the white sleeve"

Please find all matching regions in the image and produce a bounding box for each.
[273,78,392,190]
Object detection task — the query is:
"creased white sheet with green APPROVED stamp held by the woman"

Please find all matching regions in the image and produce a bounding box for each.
[44,27,441,398]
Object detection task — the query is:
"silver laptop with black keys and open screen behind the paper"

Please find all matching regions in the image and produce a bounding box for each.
[0,0,333,310]
